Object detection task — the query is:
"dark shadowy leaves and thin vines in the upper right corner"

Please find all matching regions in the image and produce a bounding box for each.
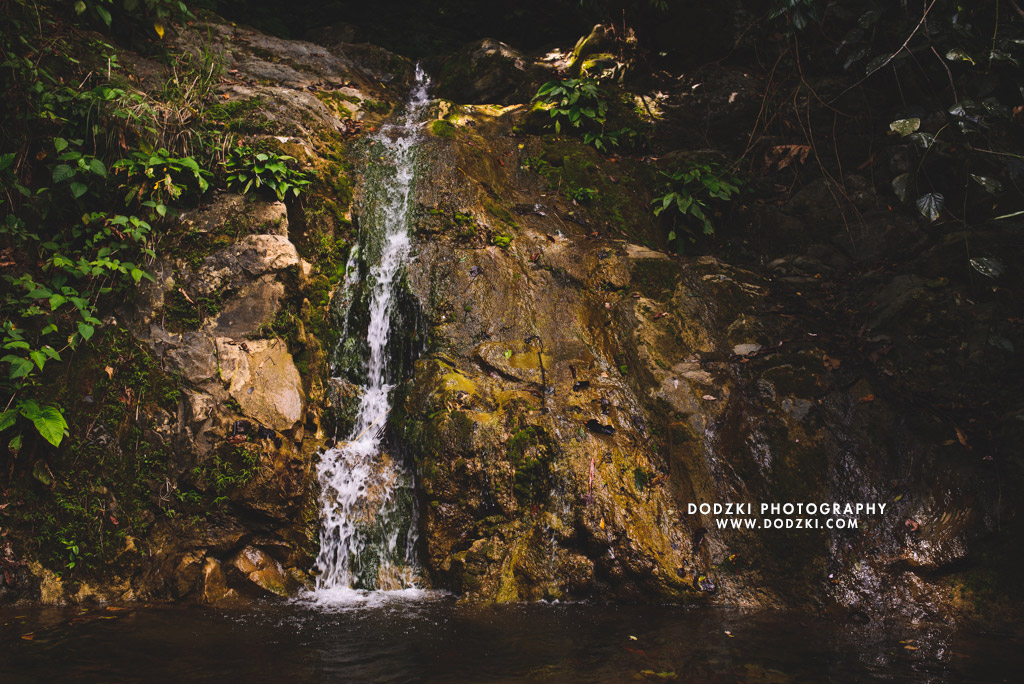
[766,0,1024,229]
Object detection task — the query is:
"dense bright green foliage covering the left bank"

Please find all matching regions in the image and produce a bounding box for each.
[0,2,210,454]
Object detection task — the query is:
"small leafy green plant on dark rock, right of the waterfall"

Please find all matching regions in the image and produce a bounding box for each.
[651,163,742,252]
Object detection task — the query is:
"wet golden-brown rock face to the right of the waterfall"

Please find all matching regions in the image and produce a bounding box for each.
[392,73,1015,619]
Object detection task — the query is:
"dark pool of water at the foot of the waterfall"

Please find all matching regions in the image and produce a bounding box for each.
[0,597,1024,684]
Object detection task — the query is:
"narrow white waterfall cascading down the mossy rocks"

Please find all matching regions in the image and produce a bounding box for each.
[312,67,429,602]
